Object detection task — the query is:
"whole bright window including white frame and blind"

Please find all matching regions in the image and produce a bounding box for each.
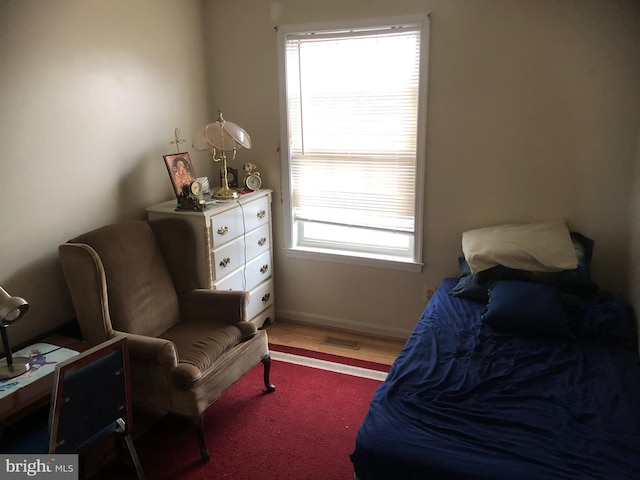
[278,16,428,270]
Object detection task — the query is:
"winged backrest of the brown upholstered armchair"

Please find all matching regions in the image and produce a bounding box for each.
[59,219,195,342]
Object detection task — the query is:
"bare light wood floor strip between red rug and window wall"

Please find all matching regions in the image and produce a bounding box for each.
[266,320,404,365]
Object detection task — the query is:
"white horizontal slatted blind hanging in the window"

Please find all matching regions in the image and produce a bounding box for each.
[286,25,420,233]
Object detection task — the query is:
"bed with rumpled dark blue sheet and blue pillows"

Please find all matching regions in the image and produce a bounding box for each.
[351,222,640,480]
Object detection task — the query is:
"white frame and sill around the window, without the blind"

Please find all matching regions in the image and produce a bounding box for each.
[277,14,429,272]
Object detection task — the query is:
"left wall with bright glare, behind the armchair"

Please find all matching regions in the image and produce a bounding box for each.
[0,0,211,344]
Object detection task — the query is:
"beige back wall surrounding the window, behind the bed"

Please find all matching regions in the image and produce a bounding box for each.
[205,0,640,337]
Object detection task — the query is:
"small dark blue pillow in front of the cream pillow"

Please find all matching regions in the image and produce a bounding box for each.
[482,280,572,338]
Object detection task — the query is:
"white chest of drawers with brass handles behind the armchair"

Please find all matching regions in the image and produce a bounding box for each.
[147,190,275,328]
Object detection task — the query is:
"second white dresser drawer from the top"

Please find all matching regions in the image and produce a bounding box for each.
[211,224,271,280]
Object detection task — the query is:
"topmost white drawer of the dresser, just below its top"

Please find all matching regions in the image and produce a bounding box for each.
[211,197,269,248]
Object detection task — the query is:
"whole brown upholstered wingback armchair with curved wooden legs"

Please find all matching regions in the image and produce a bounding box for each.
[58,218,275,461]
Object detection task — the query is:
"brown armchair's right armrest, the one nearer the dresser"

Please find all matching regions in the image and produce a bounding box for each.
[178,289,249,325]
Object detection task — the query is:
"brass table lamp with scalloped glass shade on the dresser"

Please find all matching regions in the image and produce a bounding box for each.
[193,110,251,199]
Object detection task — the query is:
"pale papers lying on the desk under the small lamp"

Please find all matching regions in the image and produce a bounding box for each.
[0,343,78,398]
